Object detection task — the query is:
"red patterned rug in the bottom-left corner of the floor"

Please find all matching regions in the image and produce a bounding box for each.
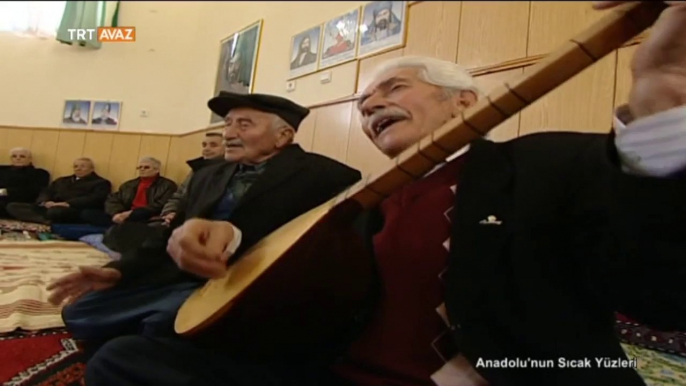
[0,329,86,386]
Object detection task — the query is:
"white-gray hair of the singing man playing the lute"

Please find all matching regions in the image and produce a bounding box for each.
[371,56,483,97]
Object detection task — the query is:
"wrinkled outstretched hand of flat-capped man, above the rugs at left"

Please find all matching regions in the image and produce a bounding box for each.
[47,267,121,305]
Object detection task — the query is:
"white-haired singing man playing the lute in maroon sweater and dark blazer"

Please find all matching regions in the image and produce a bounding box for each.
[76,2,686,386]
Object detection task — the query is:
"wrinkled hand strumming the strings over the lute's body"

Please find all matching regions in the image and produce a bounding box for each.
[167,219,234,279]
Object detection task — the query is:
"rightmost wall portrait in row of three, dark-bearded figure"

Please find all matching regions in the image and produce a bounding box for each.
[358,1,407,57]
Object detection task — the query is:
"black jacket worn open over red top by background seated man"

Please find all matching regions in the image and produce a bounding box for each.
[105,175,176,216]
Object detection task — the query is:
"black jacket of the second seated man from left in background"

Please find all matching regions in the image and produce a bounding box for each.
[36,172,112,209]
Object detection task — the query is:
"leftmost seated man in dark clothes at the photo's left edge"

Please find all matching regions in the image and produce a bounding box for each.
[0,147,50,218]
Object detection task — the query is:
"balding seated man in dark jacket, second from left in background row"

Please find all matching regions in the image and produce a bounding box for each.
[7,158,112,224]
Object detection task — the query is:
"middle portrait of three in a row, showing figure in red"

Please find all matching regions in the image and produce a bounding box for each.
[319,8,360,69]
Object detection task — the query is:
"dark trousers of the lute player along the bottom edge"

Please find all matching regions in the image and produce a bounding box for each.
[86,335,343,386]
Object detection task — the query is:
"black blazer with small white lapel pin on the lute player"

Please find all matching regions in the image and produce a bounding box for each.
[350,133,686,386]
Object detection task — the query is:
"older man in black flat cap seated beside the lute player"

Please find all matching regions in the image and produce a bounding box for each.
[49,91,360,356]
